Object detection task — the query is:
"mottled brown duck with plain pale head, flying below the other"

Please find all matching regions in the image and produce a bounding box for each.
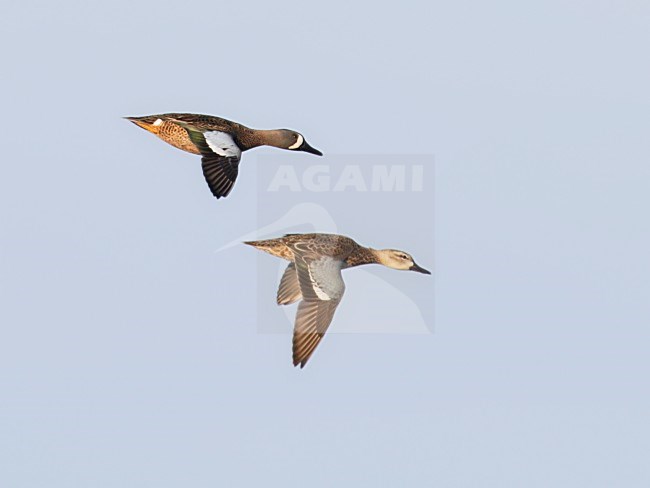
[245,234,431,368]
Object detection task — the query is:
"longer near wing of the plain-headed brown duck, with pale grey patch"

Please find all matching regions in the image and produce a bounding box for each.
[293,250,345,368]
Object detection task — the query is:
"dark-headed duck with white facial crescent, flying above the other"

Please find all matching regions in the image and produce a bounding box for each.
[125,114,323,198]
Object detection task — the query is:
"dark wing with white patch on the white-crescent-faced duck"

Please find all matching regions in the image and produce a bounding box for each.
[185,130,241,198]
